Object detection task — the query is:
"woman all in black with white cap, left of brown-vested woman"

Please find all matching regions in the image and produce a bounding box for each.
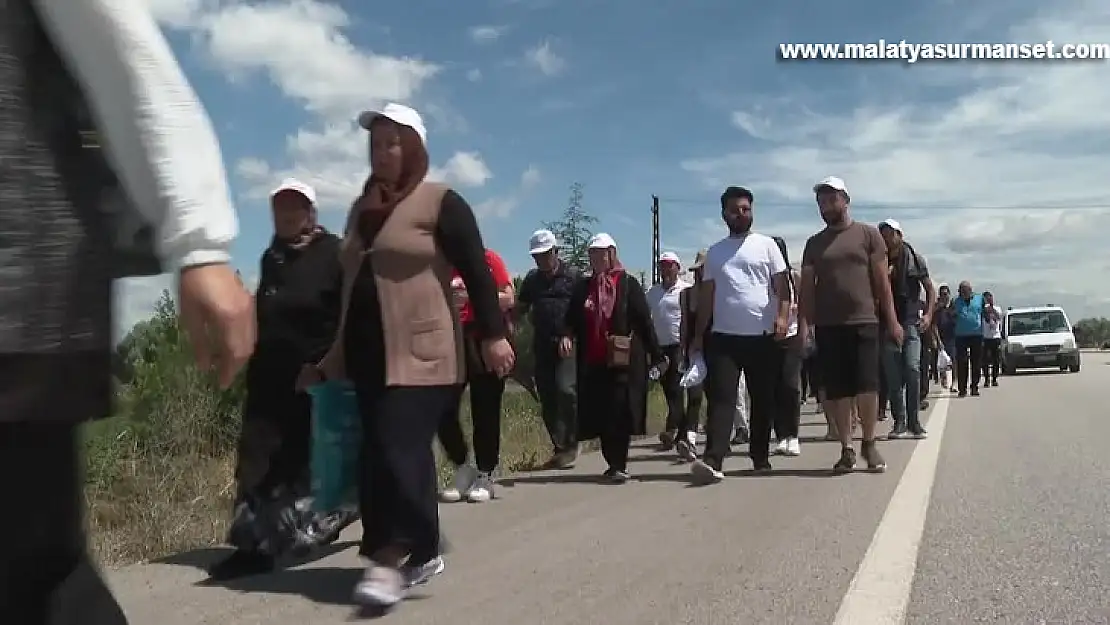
[209,178,341,579]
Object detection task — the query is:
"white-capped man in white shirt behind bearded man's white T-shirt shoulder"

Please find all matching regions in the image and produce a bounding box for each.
[647,252,690,450]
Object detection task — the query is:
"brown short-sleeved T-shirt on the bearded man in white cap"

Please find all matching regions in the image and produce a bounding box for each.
[801,221,887,326]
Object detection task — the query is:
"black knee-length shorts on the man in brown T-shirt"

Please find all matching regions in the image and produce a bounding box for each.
[814,323,880,400]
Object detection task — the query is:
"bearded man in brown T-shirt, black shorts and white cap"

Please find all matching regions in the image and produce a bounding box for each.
[799,177,902,473]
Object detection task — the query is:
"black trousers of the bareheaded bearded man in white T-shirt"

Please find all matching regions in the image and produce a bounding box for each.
[704,333,783,470]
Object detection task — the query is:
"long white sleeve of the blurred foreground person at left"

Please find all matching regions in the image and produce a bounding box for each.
[33,0,239,270]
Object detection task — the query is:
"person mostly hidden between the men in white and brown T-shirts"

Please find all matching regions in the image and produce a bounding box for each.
[771,236,805,456]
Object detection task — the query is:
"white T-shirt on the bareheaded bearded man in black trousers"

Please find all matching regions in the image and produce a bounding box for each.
[705,232,786,336]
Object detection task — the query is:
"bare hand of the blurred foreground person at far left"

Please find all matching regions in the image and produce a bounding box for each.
[178,263,256,389]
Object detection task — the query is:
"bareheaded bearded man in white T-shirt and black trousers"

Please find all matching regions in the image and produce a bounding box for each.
[692,187,791,483]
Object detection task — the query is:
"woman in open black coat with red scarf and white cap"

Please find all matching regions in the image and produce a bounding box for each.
[559,233,666,484]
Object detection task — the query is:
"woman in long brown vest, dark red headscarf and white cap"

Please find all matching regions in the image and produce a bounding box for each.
[300,103,514,608]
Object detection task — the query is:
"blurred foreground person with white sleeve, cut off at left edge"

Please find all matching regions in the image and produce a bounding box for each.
[0,0,254,625]
